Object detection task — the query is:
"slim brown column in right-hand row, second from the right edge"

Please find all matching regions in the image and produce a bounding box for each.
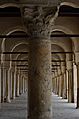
[67,61,74,103]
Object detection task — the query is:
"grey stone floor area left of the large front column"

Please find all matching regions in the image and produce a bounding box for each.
[0,94,27,119]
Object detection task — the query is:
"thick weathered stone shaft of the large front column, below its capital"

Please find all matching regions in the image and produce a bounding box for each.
[28,38,52,119]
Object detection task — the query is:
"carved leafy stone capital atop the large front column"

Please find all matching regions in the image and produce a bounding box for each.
[23,6,56,37]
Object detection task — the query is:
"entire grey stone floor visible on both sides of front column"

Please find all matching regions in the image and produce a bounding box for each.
[0,94,79,119]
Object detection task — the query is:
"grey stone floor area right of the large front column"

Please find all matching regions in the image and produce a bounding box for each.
[52,94,79,119]
